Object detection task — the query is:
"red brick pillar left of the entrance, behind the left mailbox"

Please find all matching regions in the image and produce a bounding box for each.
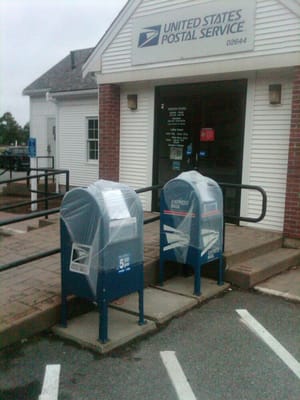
[99,85,120,181]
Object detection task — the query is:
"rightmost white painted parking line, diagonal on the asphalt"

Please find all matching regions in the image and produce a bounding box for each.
[236,310,300,379]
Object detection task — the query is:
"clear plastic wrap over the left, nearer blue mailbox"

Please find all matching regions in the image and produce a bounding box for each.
[61,180,143,294]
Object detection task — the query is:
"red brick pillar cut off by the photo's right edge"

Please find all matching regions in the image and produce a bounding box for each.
[284,66,300,240]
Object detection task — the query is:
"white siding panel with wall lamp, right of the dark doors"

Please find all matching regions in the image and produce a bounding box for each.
[245,72,292,231]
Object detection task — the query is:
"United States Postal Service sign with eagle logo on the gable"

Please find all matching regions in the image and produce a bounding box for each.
[132,0,256,65]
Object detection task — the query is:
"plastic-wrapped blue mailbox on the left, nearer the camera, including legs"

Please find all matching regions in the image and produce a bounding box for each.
[61,180,144,343]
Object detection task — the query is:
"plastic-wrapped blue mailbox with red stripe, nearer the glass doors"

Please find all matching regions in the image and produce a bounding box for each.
[160,171,223,296]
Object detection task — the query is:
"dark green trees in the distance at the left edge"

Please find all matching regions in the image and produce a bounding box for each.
[0,112,29,145]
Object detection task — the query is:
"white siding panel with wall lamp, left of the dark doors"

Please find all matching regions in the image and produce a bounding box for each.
[120,87,154,210]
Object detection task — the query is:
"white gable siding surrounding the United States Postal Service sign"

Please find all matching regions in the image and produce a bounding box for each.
[102,0,300,74]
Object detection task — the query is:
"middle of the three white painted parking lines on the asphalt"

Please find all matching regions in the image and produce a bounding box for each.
[160,351,196,400]
